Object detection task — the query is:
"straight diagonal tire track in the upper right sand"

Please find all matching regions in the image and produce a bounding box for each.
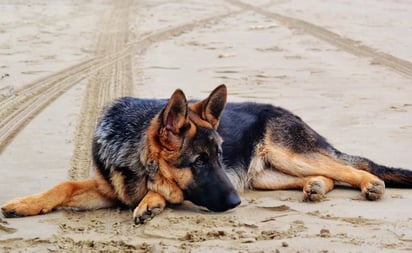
[226,0,412,78]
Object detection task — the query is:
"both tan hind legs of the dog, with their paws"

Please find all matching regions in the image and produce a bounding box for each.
[243,128,384,201]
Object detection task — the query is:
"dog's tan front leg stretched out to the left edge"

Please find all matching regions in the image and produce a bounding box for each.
[1,175,114,218]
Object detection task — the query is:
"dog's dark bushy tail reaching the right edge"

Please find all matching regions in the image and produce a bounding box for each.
[334,150,412,188]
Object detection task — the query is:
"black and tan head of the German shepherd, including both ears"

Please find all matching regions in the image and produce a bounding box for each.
[148,85,240,212]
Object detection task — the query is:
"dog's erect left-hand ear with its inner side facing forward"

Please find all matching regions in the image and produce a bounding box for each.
[162,89,188,134]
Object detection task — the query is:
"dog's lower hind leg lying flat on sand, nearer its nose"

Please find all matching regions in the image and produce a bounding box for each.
[251,169,334,201]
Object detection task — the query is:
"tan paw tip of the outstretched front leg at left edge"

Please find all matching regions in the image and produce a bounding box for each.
[1,195,51,218]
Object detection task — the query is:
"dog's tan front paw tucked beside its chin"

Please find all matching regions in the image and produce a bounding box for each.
[133,191,166,224]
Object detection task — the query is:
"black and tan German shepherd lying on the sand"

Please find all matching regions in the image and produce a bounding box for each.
[2,85,412,224]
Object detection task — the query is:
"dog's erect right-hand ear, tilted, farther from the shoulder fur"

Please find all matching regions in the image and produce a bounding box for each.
[191,84,227,129]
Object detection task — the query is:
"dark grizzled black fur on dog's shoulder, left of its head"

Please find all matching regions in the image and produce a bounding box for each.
[92,97,167,206]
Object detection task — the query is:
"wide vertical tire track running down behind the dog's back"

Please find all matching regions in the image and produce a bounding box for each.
[69,1,132,180]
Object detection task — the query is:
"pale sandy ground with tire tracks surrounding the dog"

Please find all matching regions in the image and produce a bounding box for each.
[0,0,412,252]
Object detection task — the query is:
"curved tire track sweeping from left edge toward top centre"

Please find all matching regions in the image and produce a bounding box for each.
[0,6,244,156]
